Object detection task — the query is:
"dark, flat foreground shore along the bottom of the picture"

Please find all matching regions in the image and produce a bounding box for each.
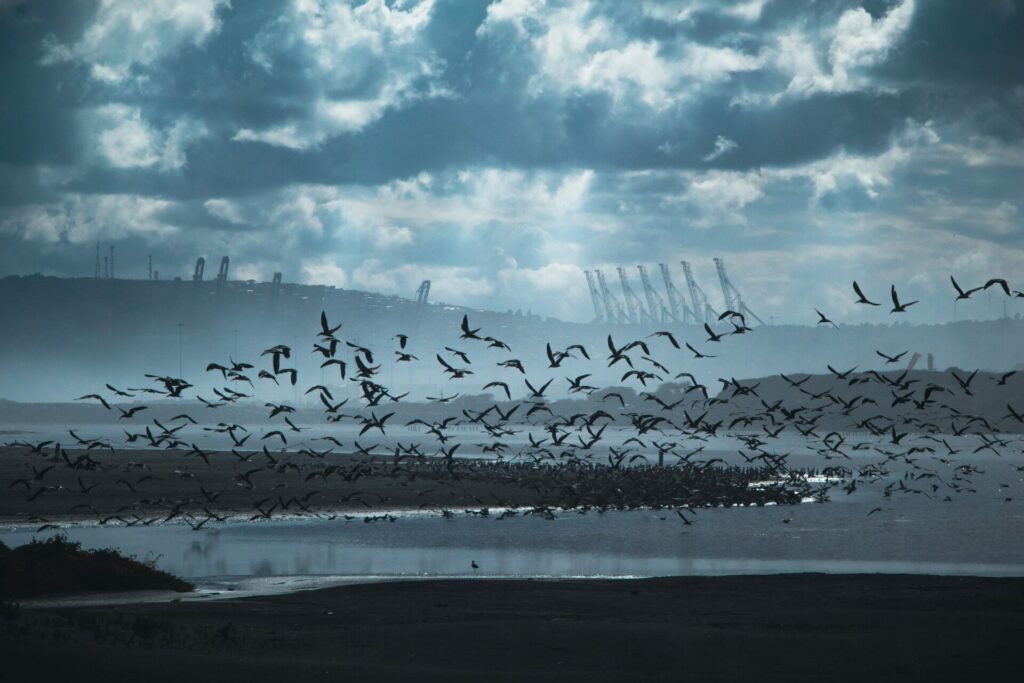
[0,574,1024,683]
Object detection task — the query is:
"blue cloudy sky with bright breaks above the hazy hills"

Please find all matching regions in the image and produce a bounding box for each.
[0,0,1024,324]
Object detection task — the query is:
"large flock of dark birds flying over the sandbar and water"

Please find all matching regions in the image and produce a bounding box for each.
[7,278,1024,530]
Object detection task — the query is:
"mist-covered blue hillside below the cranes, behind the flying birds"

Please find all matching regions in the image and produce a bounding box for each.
[0,278,1024,403]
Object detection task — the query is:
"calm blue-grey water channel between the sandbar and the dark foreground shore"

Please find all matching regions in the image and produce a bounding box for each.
[0,496,1024,578]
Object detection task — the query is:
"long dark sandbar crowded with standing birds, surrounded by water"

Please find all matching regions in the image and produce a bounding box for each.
[0,447,805,525]
